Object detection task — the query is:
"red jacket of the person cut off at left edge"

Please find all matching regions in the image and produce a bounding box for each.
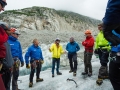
[0,27,8,59]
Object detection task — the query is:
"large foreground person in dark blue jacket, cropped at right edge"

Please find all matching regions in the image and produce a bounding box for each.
[103,0,120,90]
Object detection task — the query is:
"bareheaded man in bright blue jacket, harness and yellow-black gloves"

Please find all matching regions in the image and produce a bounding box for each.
[25,39,44,87]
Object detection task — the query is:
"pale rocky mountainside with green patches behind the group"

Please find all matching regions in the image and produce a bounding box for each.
[0,7,101,48]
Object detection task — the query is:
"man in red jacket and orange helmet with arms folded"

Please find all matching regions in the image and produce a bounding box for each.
[82,30,94,76]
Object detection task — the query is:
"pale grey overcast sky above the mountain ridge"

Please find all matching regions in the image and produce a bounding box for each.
[5,0,108,20]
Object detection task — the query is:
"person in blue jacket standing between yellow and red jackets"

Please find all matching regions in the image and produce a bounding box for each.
[66,37,80,76]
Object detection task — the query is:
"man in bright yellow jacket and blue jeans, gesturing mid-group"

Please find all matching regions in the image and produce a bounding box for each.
[49,38,65,77]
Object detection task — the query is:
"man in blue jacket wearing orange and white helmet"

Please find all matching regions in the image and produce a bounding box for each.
[8,28,24,90]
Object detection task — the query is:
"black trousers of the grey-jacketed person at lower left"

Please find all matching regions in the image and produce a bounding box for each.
[2,69,11,90]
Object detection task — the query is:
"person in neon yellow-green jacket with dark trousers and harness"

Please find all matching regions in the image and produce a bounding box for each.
[94,24,111,85]
